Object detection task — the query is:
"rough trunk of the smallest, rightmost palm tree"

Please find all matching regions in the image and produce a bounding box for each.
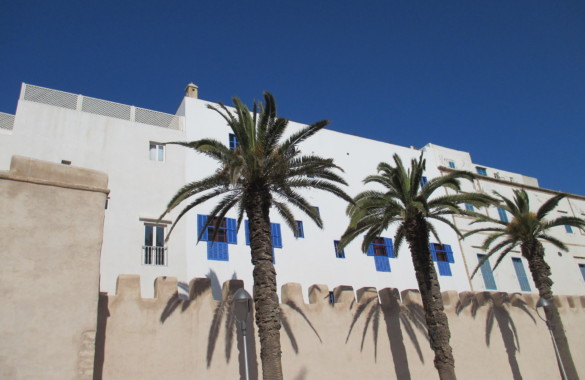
[521,240,579,380]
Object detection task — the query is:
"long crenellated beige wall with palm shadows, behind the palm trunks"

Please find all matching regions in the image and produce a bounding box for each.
[98,276,585,380]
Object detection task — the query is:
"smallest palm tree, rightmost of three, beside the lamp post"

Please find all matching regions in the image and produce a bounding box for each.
[465,190,585,379]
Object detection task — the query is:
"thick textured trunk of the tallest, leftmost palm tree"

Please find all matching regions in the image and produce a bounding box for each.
[245,191,283,380]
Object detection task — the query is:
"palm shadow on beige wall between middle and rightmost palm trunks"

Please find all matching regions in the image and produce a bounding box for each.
[455,292,536,380]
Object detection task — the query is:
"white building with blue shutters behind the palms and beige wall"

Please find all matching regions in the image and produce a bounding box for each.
[0,84,585,297]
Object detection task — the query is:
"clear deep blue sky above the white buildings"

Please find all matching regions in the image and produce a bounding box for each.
[0,0,585,195]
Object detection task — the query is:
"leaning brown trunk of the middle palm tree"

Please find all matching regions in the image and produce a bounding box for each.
[405,217,457,380]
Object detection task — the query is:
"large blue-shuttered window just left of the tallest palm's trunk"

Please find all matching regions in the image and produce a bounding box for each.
[197,215,238,261]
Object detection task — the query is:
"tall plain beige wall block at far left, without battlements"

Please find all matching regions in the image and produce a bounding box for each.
[0,157,107,380]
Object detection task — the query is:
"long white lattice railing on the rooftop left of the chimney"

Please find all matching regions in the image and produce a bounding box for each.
[21,84,183,131]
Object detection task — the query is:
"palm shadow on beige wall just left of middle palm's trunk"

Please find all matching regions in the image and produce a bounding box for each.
[345,289,429,380]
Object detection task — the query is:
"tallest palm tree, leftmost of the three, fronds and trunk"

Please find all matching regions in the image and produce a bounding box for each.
[160,92,351,379]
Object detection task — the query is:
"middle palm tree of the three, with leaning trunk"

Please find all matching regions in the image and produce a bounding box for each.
[339,154,489,379]
